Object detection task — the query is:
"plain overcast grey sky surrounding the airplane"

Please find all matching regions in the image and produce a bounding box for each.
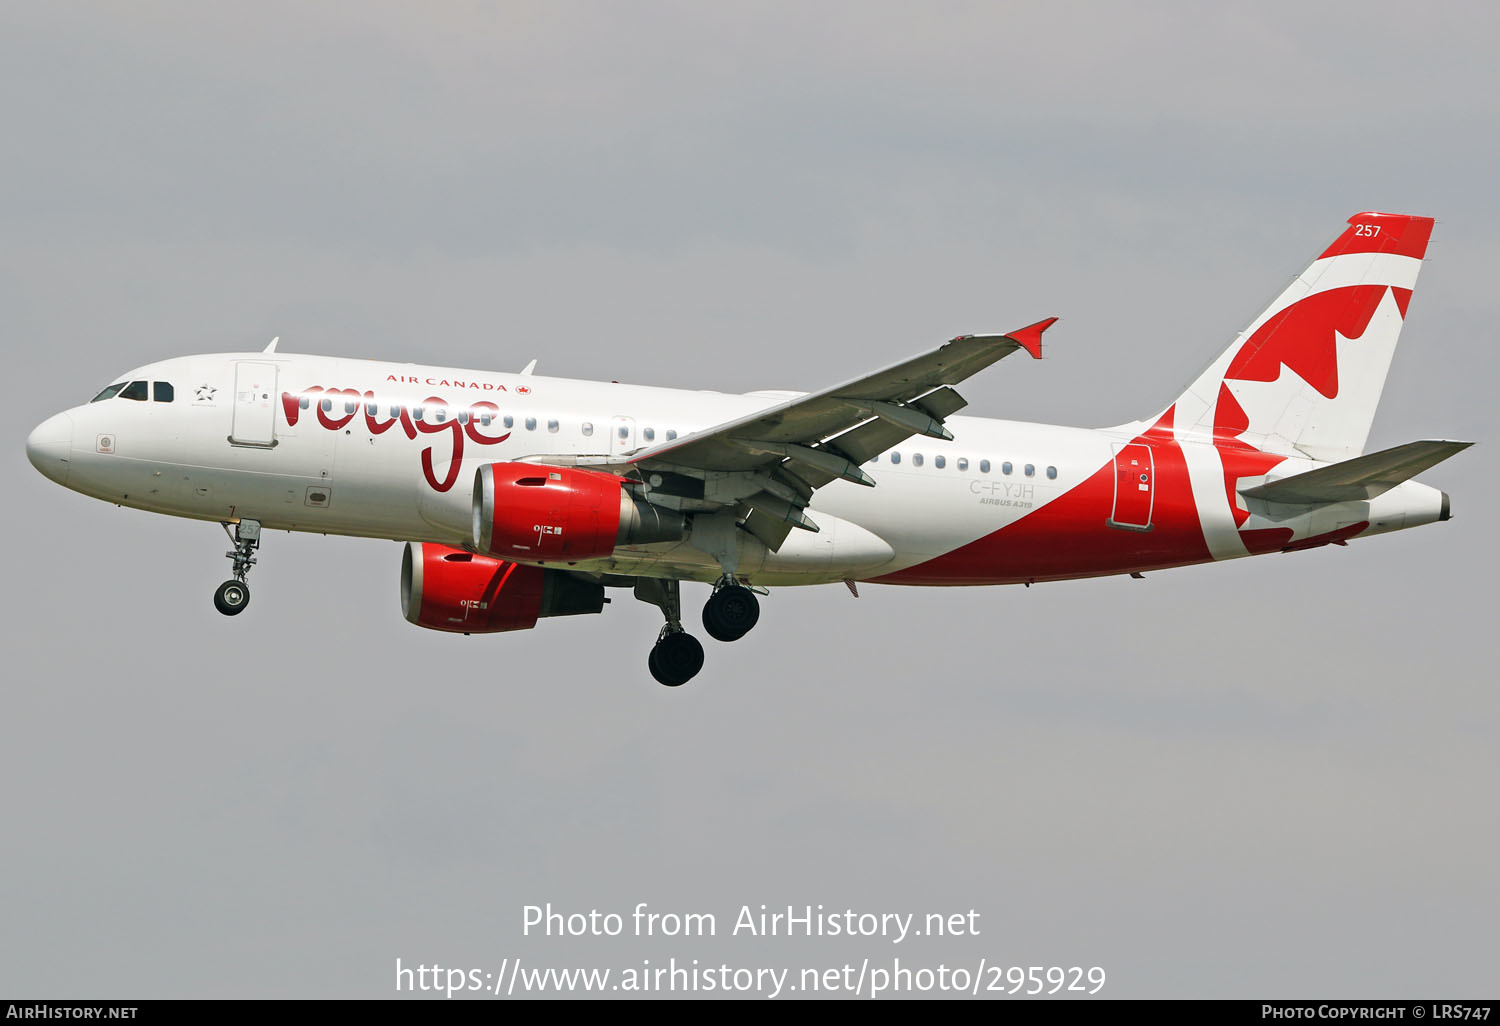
[0,2,1500,998]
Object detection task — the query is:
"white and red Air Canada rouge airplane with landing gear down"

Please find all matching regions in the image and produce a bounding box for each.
[26,212,1472,687]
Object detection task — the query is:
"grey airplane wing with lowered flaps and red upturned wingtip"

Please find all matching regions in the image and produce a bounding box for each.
[578,317,1058,551]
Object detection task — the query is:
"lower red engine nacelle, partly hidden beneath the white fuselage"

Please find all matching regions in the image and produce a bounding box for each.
[401,542,605,635]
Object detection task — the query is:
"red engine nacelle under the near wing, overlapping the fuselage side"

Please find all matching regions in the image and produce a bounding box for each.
[474,464,687,563]
